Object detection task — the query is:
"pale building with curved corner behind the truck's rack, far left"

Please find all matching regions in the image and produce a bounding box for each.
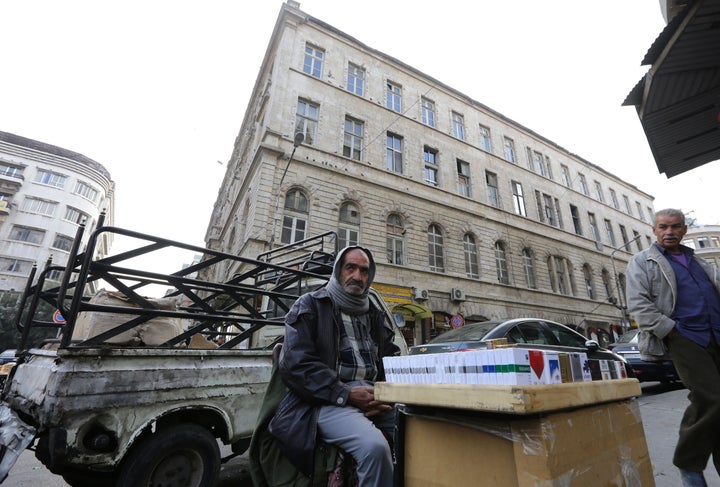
[0,132,114,291]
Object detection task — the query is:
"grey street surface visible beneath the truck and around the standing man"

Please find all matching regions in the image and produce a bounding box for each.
[3,382,720,487]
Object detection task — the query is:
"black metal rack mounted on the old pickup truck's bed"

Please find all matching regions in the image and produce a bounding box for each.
[16,217,338,351]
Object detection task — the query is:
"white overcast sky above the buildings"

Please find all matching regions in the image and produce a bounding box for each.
[0,0,720,262]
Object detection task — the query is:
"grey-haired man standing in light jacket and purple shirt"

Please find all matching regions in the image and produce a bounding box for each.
[627,209,720,487]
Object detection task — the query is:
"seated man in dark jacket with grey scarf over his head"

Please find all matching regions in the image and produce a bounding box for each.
[269,246,400,487]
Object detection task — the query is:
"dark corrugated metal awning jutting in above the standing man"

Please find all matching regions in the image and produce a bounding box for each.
[623,0,720,177]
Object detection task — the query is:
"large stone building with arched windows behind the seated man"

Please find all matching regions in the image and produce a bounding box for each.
[206,1,653,343]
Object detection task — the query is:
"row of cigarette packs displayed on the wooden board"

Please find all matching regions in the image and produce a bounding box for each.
[383,347,627,386]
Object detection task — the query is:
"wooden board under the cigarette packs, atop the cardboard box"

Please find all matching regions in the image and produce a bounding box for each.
[375,379,642,414]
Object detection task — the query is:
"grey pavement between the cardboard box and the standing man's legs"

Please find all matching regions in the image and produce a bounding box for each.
[638,382,720,487]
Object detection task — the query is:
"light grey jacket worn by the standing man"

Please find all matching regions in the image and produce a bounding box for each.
[626,244,720,360]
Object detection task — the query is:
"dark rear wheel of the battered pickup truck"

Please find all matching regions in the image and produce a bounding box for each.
[118,423,220,487]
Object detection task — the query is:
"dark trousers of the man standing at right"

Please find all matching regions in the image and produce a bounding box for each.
[666,329,720,473]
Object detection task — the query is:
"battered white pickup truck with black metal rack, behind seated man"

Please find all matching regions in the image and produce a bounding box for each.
[0,220,407,487]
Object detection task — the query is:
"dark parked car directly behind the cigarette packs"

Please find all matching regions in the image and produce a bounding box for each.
[409,318,635,377]
